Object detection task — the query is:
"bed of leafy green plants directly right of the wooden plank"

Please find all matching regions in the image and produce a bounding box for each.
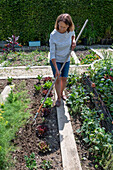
[67,75,113,170]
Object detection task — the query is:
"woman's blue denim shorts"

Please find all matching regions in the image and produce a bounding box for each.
[50,60,70,77]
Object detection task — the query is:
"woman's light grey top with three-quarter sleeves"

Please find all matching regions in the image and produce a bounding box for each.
[50,29,75,63]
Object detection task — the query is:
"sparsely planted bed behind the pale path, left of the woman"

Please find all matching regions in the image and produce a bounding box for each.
[0,50,48,67]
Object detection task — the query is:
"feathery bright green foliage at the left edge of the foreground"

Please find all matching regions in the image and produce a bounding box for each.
[0,80,30,170]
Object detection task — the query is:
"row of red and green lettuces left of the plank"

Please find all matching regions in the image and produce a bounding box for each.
[34,75,53,169]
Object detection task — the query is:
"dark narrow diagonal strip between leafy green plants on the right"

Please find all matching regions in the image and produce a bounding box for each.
[83,73,113,132]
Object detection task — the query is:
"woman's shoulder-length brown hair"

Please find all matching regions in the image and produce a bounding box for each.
[55,14,75,32]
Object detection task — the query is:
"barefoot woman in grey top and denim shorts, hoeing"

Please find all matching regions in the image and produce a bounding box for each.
[50,14,76,107]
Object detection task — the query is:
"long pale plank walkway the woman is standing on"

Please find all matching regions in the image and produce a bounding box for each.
[55,92,82,170]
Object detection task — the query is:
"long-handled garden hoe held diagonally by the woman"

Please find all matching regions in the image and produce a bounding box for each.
[33,19,88,125]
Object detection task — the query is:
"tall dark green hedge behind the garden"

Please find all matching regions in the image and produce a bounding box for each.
[0,0,113,45]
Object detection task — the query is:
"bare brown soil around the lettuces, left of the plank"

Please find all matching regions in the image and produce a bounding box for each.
[0,79,62,170]
